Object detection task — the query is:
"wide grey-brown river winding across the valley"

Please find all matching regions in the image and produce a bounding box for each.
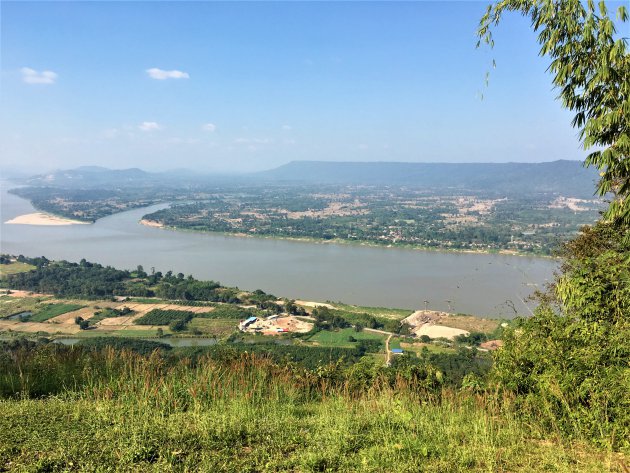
[0,182,556,318]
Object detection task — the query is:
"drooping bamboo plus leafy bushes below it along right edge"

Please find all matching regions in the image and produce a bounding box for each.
[479,0,630,448]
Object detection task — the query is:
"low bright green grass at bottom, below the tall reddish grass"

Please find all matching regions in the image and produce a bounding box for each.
[0,394,623,472]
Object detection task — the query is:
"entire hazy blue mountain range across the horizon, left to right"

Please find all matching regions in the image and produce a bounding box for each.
[22,160,598,198]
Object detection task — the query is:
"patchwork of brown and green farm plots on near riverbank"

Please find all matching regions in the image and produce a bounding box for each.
[0,290,488,348]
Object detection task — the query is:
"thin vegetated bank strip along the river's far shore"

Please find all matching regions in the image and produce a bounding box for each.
[138,218,559,260]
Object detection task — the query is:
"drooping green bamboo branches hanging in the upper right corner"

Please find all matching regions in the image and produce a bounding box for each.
[477,0,630,229]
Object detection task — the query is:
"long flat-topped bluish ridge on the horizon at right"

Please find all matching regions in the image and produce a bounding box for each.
[259,160,598,198]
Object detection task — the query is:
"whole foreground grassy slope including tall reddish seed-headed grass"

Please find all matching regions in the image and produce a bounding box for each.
[0,350,627,473]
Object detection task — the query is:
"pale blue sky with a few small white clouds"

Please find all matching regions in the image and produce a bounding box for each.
[0,1,604,171]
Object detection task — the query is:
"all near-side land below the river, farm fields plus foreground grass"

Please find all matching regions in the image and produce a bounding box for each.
[0,255,627,473]
